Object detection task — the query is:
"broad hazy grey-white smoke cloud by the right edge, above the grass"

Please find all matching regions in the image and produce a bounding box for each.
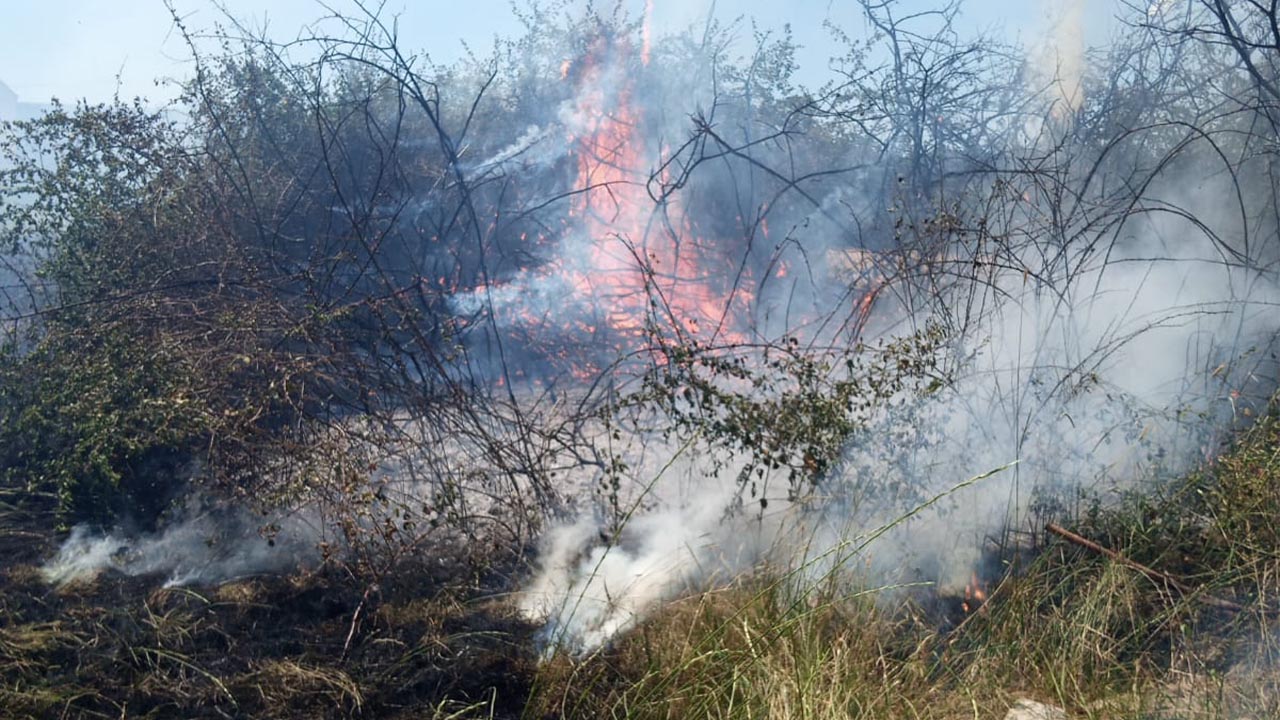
[837,239,1280,588]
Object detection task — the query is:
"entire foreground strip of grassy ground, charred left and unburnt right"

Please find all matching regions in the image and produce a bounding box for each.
[0,419,1280,720]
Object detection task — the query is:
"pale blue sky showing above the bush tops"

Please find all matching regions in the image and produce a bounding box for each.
[0,0,1115,102]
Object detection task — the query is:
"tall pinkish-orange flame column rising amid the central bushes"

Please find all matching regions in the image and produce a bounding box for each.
[552,29,749,348]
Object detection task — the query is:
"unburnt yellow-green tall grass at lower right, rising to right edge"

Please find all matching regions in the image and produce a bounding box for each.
[525,416,1280,720]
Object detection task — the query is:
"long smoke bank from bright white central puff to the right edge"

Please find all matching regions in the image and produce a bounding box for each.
[520,162,1280,652]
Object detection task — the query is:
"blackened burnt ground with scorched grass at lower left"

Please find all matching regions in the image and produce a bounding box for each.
[0,520,536,719]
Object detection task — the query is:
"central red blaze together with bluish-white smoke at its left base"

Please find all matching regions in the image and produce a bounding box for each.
[471,22,757,382]
